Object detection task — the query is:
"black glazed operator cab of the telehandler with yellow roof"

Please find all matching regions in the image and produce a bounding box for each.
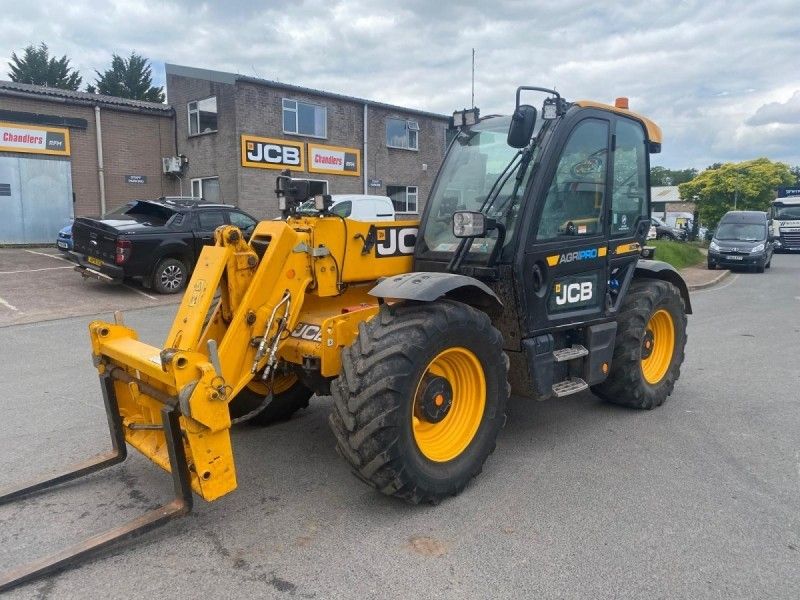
[414,87,668,350]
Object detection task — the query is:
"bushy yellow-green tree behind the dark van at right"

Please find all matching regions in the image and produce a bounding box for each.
[679,158,795,228]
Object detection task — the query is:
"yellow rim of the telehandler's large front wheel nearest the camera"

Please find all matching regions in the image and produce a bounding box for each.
[411,347,486,462]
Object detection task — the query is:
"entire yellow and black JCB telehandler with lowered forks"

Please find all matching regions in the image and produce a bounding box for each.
[0,87,691,589]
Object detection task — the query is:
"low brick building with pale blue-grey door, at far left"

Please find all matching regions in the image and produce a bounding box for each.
[0,81,177,243]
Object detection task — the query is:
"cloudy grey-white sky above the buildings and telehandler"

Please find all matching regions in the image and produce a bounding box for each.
[0,0,800,169]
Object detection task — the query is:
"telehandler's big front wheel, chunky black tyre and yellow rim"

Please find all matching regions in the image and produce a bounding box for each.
[329,300,510,504]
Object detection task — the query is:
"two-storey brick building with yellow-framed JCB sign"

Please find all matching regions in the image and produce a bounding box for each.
[166,64,449,218]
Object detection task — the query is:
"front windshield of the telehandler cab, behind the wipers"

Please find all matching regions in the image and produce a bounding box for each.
[423,117,535,262]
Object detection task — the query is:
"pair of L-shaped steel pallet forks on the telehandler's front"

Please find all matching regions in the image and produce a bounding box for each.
[0,370,192,592]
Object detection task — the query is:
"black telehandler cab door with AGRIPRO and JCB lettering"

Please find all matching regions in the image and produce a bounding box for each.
[523,116,612,335]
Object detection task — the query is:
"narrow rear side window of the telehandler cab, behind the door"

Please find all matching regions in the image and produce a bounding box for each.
[611,119,648,235]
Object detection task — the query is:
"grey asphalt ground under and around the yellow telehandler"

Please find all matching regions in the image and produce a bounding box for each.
[0,255,800,599]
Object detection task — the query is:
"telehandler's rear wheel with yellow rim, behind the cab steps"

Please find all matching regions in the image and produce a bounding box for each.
[592,279,686,410]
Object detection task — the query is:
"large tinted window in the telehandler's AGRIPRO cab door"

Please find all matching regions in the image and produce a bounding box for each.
[536,119,608,240]
